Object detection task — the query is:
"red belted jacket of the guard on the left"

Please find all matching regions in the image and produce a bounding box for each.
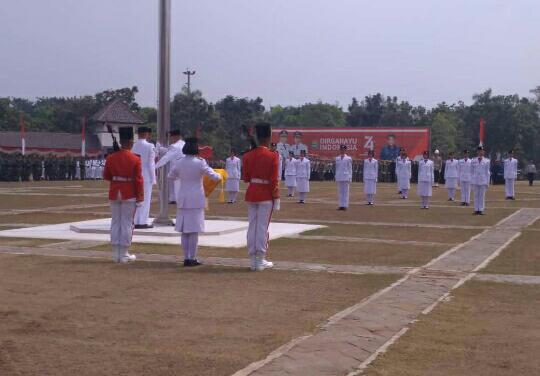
[103,149,144,201]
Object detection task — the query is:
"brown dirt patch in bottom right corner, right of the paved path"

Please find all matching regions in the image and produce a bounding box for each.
[363,282,540,376]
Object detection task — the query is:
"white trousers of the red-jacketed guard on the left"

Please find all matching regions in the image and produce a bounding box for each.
[110,199,135,247]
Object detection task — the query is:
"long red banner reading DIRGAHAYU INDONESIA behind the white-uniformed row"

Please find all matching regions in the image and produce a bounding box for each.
[272,127,430,160]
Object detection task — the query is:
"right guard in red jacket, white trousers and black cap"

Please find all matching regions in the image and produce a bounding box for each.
[242,122,279,271]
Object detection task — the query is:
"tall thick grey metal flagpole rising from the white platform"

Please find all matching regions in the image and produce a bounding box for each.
[154,0,171,225]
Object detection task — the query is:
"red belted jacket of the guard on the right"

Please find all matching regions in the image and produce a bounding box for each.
[242,146,279,202]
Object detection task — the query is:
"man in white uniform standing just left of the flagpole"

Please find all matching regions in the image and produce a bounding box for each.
[131,127,156,229]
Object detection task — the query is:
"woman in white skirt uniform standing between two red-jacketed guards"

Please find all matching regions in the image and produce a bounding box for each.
[168,138,221,267]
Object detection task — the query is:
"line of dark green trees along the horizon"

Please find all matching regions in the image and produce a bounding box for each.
[0,86,540,161]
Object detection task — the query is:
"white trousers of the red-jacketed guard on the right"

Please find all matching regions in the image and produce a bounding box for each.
[247,201,274,256]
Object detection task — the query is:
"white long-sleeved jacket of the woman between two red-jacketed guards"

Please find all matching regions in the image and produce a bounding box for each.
[168,155,221,209]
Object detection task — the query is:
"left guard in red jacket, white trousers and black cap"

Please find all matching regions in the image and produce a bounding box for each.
[103,127,144,263]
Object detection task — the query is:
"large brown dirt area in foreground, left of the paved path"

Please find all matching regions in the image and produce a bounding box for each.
[0,255,397,376]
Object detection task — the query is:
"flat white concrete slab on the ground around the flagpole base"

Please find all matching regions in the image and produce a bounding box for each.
[0,218,325,248]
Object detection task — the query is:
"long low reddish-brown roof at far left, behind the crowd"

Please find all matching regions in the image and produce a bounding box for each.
[0,132,101,151]
